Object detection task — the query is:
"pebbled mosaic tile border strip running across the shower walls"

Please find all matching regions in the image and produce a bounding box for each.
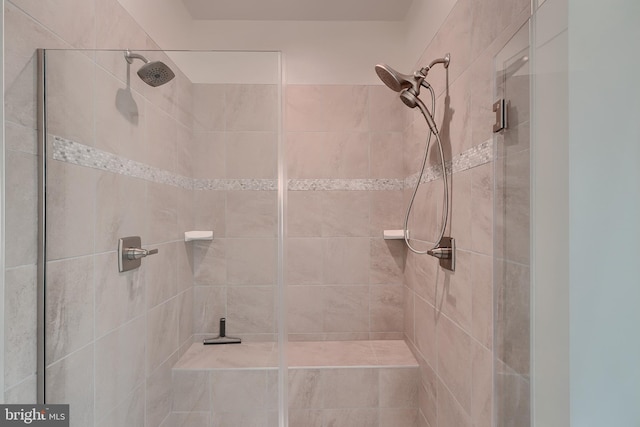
[50,135,494,191]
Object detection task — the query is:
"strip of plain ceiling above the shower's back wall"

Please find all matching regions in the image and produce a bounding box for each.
[182,0,413,21]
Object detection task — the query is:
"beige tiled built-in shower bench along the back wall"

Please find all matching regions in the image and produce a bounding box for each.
[162,340,419,427]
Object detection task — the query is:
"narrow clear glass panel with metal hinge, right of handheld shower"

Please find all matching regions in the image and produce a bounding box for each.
[494,23,530,427]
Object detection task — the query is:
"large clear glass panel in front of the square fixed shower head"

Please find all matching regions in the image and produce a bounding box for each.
[43,50,282,427]
